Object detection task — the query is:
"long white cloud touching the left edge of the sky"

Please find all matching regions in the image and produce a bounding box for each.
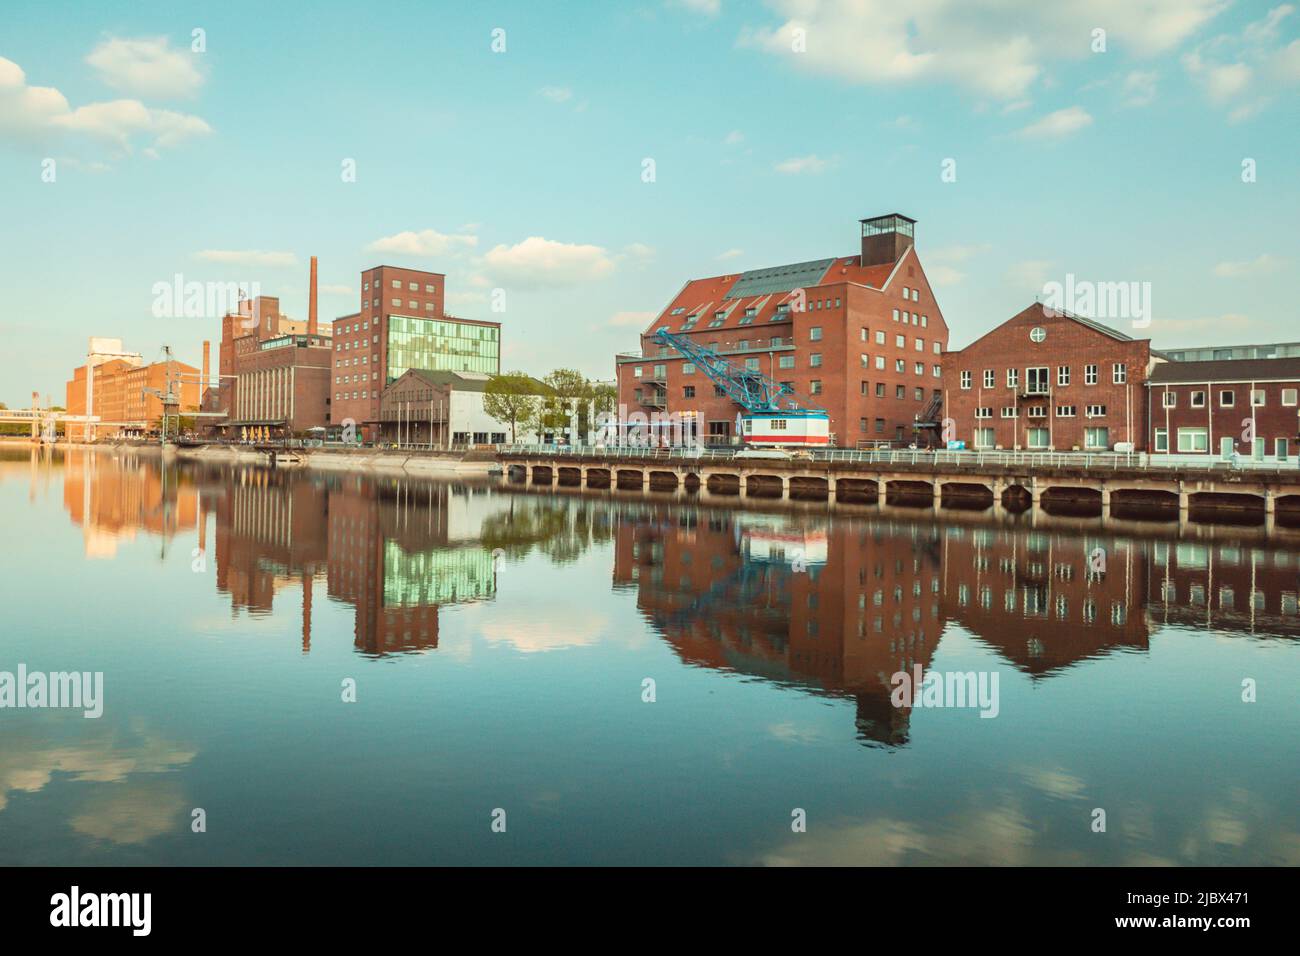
[0,57,212,159]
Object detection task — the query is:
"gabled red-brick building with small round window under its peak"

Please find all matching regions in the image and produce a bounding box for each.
[943,303,1164,451]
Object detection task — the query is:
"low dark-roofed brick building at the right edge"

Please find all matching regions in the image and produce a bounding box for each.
[1147,358,1300,462]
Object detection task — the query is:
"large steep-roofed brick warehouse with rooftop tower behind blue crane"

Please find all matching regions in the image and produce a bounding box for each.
[615,213,948,447]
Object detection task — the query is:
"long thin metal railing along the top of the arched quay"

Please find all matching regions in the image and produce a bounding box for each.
[497,445,1300,473]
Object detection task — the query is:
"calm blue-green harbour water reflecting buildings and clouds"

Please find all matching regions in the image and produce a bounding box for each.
[0,449,1300,865]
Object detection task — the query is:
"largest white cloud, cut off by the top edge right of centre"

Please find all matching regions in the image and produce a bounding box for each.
[738,0,1226,100]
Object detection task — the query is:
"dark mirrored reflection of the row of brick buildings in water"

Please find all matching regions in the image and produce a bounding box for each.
[34,451,1300,723]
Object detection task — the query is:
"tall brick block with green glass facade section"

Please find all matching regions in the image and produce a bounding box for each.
[330,265,501,440]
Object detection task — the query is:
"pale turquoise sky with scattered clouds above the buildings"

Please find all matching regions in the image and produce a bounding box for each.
[0,0,1300,407]
